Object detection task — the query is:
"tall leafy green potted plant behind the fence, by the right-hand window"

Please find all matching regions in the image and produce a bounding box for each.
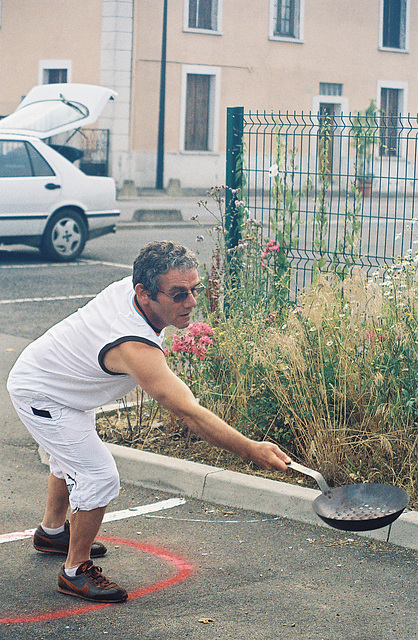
[351,100,380,196]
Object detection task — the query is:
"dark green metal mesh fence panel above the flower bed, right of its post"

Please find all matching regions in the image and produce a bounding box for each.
[227,108,418,295]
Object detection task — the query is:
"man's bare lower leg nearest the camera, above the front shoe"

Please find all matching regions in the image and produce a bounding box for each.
[65,507,106,569]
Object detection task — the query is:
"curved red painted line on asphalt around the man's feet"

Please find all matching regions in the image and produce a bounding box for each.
[0,536,193,624]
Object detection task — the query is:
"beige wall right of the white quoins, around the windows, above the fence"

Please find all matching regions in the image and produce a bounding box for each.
[131,0,418,187]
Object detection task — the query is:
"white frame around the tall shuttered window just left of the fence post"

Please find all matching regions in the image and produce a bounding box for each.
[179,65,221,155]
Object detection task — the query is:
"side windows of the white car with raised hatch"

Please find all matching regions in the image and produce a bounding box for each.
[0,140,54,178]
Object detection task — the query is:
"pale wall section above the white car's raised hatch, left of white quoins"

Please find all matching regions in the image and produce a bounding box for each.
[0,0,102,116]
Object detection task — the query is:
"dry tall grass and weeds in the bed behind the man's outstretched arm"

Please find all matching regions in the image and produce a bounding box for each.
[195,259,418,500]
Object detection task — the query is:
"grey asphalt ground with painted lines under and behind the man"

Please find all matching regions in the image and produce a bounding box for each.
[0,221,418,640]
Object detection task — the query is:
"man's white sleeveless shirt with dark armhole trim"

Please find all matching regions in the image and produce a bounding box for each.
[7,276,164,411]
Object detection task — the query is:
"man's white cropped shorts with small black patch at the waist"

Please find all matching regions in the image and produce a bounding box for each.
[11,395,119,512]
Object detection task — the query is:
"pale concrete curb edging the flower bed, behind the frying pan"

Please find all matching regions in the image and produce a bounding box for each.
[103,444,418,549]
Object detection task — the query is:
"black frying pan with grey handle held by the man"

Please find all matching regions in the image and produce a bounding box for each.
[288,461,409,531]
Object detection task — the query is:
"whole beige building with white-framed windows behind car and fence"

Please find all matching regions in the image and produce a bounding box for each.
[0,0,418,188]
